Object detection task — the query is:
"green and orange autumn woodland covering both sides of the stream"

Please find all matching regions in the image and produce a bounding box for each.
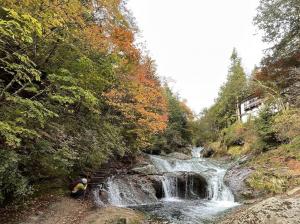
[0,0,300,220]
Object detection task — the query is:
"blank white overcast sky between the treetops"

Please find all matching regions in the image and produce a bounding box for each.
[128,0,266,113]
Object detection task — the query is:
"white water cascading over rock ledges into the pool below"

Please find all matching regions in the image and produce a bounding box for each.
[107,148,237,224]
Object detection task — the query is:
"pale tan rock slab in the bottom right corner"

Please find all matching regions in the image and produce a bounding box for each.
[220,192,300,224]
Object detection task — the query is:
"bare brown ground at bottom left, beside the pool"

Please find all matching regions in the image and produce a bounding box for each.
[0,196,148,224]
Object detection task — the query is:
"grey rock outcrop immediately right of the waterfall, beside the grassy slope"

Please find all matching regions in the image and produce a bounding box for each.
[224,165,257,201]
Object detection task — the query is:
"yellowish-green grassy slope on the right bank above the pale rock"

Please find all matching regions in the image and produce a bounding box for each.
[246,138,300,194]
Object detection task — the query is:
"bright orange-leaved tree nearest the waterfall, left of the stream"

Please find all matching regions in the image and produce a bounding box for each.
[104,58,168,150]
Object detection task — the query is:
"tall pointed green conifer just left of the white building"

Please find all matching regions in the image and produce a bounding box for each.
[196,49,247,145]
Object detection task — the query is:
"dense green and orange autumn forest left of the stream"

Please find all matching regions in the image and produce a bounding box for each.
[0,0,193,204]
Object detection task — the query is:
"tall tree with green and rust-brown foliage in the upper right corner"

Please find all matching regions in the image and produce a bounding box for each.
[254,0,300,106]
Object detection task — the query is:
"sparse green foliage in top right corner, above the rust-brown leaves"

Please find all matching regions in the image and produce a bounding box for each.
[254,0,300,57]
